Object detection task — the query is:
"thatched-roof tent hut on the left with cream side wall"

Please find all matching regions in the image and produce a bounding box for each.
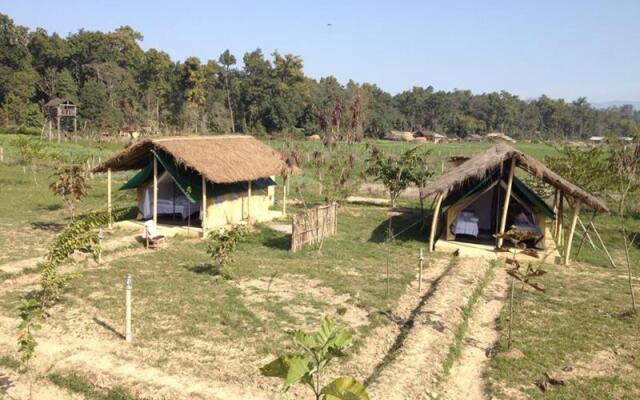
[93,135,286,232]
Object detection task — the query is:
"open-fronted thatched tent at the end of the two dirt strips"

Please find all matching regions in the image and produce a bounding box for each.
[423,144,609,263]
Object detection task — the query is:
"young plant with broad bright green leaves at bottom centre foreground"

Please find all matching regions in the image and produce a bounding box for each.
[260,317,369,400]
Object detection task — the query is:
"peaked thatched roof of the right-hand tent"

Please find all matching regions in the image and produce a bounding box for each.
[424,143,609,212]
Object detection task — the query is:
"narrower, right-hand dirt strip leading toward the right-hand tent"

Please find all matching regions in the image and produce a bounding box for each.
[440,268,509,400]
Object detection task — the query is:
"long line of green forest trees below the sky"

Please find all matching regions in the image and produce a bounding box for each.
[0,14,640,140]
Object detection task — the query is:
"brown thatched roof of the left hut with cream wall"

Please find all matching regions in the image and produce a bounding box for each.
[93,135,287,183]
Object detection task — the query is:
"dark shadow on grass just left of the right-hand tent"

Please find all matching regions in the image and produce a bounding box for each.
[369,210,431,243]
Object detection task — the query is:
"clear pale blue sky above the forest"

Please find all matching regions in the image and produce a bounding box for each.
[0,0,640,102]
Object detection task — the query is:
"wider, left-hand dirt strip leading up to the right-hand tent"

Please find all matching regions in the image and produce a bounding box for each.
[366,258,488,400]
